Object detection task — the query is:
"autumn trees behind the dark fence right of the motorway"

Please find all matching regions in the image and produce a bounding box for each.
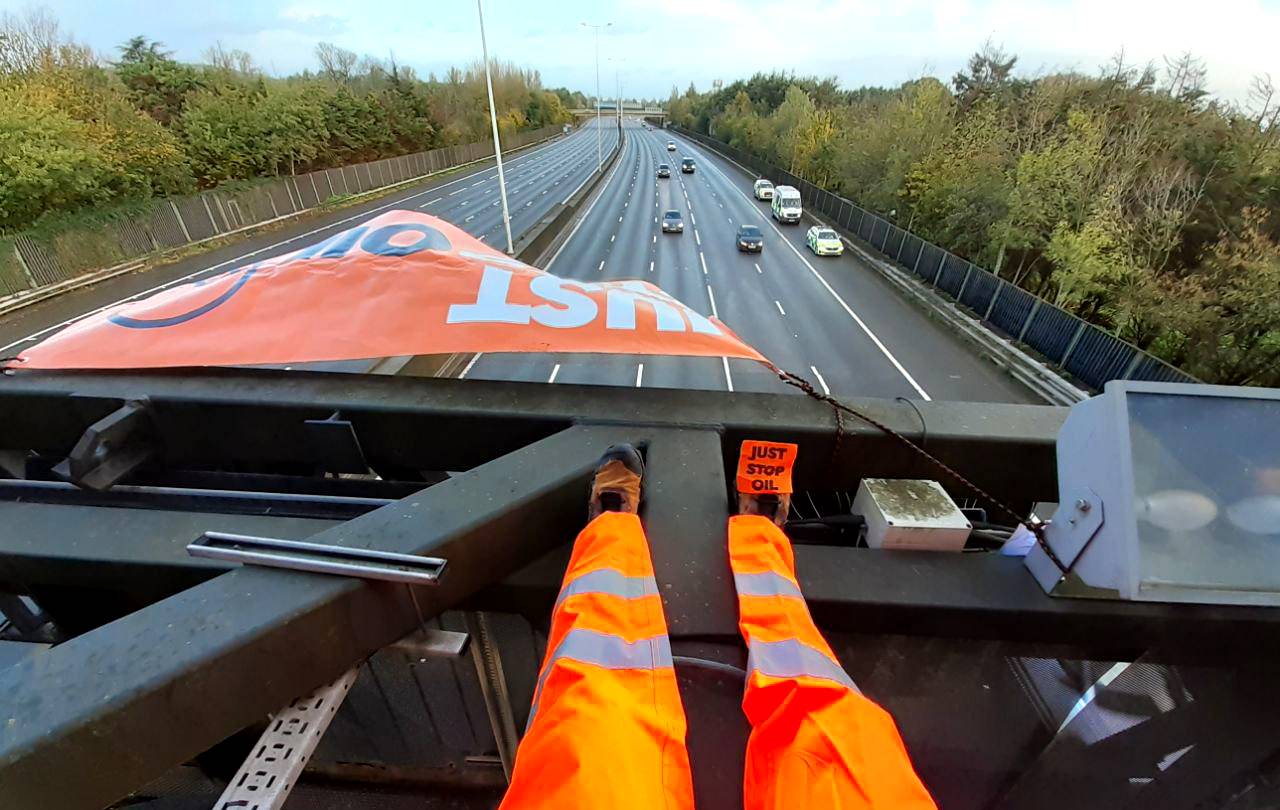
[667,45,1280,385]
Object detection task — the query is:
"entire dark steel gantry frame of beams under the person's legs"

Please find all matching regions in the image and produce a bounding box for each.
[0,370,1280,806]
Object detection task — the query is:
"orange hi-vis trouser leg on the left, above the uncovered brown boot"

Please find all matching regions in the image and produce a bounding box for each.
[502,512,694,810]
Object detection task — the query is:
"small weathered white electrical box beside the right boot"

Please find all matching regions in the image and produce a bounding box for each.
[854,479,973,552]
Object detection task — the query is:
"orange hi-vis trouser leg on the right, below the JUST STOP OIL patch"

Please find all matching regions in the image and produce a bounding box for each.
[728,516,934,810]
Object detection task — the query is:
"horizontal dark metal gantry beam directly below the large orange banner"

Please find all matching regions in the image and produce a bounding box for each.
[0,369,1066,504]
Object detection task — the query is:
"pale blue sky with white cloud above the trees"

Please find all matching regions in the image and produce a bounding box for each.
[20,0,1280,102]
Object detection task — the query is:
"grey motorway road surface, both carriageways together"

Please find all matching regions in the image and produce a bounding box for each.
[0,119,1039,402]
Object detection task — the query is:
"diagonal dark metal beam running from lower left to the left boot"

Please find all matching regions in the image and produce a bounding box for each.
[0,427,631,807]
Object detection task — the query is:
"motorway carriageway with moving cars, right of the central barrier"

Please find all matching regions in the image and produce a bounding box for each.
[465,122,1041,402]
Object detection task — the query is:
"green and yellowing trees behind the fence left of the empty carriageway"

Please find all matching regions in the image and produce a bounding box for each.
[0,10,584,232]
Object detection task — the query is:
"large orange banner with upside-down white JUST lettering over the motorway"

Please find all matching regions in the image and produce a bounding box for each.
[10,211,768,369]
